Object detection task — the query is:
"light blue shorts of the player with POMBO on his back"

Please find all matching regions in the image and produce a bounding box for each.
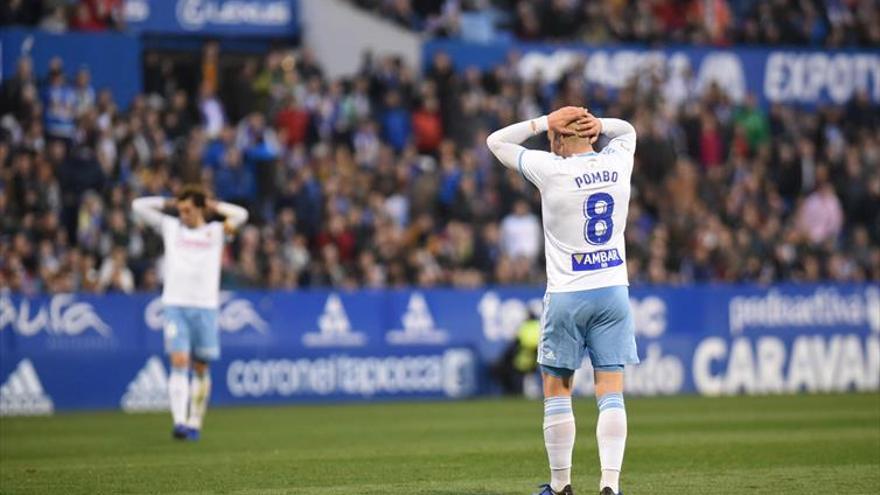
[538,285,639,375]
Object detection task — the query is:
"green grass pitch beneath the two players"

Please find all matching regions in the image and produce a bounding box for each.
[0,394,880,495]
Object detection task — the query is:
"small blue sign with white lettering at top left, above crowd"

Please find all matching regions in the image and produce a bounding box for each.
[125,0,299,37]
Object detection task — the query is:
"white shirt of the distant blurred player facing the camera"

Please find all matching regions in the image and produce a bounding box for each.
[162,219,225,308]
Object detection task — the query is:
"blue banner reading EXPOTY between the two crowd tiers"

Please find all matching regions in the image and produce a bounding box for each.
[423,41,880,106]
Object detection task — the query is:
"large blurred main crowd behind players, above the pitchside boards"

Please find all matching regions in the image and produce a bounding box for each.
[0,43,880,293]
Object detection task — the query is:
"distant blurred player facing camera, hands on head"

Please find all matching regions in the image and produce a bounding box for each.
[132,186,248,440]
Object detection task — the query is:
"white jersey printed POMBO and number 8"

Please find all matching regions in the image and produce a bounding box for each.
[519,126,636,292]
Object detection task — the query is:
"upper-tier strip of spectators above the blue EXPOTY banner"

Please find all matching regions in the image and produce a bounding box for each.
[352,0,880,47]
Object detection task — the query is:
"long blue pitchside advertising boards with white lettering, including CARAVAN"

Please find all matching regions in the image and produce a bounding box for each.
[0,284,880,415]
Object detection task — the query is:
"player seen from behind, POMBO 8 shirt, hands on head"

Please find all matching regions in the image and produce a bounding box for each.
[486,107,639,495]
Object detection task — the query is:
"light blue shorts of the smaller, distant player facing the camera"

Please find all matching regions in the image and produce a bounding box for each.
[164,306,220,361]
